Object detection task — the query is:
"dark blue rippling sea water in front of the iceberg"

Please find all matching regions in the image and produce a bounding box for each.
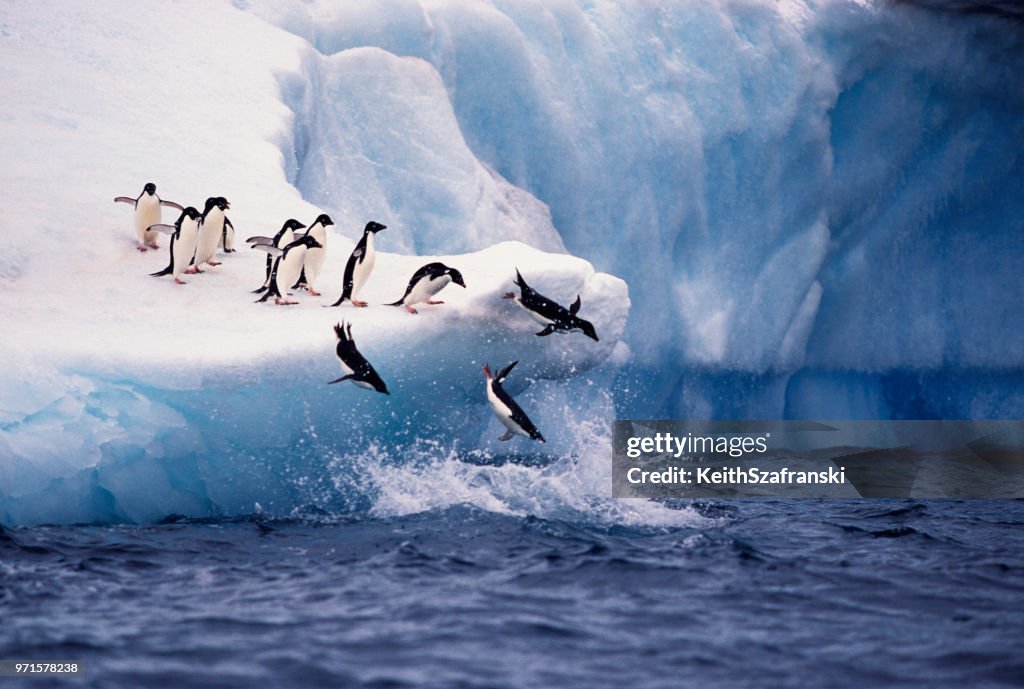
[0,501,1024,689]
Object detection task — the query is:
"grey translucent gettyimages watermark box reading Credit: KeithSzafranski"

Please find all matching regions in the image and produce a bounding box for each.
[612,421,1024,499]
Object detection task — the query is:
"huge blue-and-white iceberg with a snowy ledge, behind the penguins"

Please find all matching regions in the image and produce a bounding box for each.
[0,0,1024,523]
